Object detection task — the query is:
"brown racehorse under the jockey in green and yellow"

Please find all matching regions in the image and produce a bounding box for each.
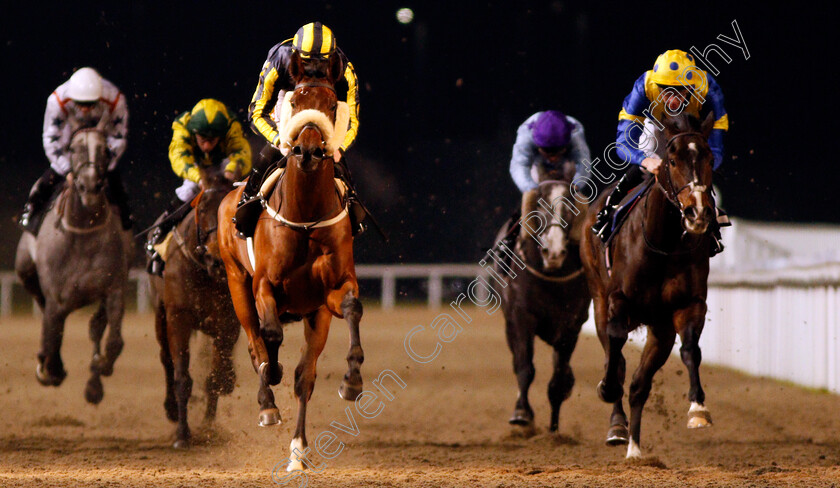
[150,171,239,449]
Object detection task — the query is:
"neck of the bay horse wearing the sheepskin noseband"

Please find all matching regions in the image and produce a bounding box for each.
[275,161,341,222]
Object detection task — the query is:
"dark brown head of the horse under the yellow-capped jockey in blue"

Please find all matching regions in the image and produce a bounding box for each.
[657,113,715,234]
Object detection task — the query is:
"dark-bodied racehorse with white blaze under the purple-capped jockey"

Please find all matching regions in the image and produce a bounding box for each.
[494,180,590,432]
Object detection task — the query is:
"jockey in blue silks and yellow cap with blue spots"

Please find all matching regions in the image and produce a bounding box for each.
[592,50,729,255]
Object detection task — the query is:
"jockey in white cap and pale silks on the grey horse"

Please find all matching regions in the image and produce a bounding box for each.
[18,68,132,234]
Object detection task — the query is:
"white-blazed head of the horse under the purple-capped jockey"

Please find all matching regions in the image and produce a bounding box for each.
[517,180,578,273]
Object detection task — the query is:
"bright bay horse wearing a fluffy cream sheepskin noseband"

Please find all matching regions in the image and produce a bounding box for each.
[219,51,364,471]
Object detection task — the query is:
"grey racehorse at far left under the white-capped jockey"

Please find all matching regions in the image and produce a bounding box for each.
[15,129,131,404]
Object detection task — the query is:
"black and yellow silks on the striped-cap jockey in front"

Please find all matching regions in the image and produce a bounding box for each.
[248,39,359,150]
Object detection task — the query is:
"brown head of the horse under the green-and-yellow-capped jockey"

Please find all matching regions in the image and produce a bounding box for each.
[192,170,233,279]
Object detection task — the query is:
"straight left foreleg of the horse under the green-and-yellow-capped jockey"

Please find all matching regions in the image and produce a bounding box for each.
[166,309,195,449]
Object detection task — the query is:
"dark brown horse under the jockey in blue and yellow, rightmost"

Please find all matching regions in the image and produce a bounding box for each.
[581,115,715,458]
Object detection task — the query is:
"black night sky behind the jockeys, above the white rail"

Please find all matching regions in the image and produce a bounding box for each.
[0,0,840,269]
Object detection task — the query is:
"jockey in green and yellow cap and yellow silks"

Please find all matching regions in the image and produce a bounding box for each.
[146,98,251,276]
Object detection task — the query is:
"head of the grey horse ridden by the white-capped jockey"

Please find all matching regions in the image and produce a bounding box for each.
[70,129,108,207]
